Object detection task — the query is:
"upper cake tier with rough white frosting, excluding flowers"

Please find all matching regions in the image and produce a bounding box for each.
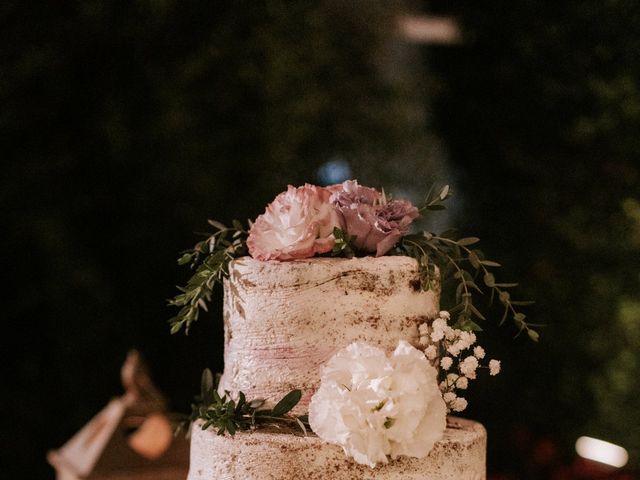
[219,256,440,413]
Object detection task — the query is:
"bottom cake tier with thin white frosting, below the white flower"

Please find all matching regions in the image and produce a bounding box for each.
[188,417,487,480]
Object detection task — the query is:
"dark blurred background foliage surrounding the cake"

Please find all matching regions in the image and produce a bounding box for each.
[0,0,640,478]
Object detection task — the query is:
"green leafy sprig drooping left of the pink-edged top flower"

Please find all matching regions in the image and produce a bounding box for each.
[169,220,248,334]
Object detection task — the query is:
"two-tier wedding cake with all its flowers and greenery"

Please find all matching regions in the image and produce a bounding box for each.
[171,181,524,480]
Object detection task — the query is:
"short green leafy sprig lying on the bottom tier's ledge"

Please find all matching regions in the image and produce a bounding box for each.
[178,369,309,435]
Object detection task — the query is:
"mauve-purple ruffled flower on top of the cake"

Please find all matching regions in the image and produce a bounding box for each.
[331,180,418,257]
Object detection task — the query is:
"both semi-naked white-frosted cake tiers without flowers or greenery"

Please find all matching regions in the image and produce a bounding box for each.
[189,256,486,480]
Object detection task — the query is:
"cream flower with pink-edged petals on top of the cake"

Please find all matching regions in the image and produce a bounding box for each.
[247,184,340,260]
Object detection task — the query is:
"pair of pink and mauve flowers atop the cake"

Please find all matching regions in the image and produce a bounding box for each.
[247,180,419,260]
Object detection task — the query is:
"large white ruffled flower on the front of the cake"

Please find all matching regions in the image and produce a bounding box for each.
[309,341,447,467]
